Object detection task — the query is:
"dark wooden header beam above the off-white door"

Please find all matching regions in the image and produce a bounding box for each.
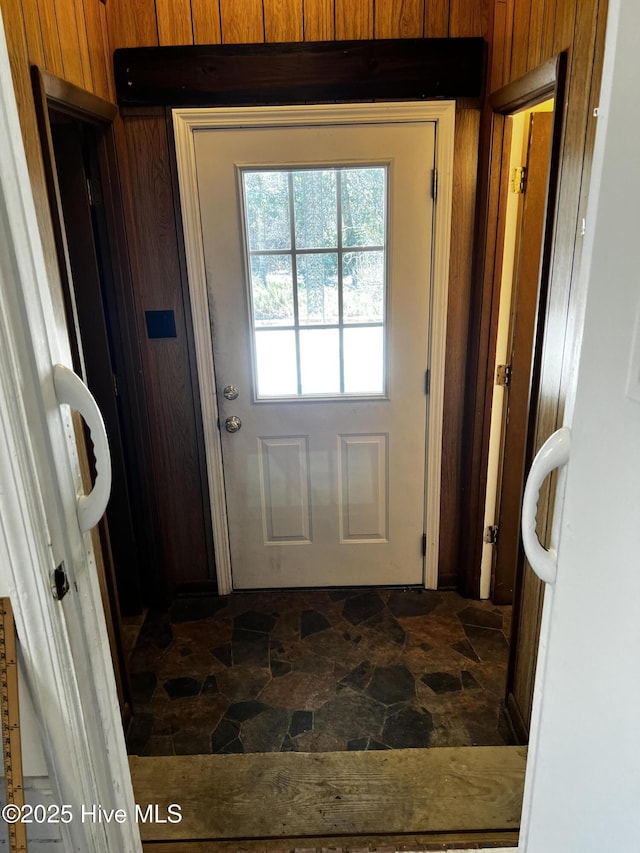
[114,38,485,107]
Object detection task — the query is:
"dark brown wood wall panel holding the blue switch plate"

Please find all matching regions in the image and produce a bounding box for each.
[118,115,214,585]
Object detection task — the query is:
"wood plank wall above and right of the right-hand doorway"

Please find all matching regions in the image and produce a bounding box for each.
[490,0,608,524]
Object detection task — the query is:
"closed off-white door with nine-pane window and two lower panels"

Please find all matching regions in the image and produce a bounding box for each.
[195,122,435,589]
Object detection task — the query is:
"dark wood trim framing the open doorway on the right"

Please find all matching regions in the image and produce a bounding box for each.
[459,53,567,598]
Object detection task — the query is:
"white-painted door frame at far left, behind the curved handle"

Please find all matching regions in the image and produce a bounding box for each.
[0,8,142,853]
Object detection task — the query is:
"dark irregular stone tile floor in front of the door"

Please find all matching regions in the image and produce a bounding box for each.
[128,589,512,755]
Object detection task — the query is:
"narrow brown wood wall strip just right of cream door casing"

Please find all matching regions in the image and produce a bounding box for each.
[438,110,480,578]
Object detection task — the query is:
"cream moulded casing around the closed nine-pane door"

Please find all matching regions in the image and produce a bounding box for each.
[173,101,455,595]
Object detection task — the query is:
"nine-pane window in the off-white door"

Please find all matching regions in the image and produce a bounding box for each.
[241,164,388,400]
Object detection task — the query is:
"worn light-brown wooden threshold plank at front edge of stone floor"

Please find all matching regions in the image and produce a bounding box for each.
[130,746,526,849]
